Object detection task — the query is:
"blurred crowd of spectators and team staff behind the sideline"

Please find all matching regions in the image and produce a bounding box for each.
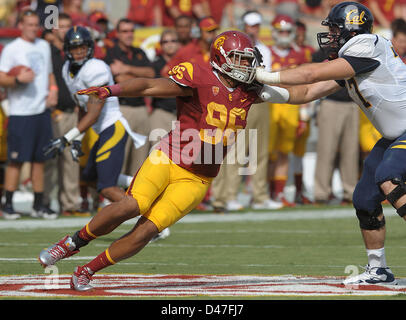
[0,0,406,216]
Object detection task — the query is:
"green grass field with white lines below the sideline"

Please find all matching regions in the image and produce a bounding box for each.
[0,207,406,298]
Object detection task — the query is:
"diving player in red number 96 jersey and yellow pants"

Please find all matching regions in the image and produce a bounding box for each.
[39,31,288,291]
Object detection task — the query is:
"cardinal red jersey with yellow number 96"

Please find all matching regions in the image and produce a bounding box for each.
[159,62,258,177]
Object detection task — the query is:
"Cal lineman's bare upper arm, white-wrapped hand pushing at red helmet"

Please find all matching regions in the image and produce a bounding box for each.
[256,58,355,86]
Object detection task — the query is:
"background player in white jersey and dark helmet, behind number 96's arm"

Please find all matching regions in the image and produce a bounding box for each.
[44,26,146,202]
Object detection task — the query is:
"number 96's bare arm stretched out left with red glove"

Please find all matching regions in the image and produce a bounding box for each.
[77,78,193,99]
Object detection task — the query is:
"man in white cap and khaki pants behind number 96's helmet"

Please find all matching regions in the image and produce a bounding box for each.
[212,11,282,211]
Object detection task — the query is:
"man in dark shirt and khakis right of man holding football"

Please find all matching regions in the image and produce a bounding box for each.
[44,13,89,216]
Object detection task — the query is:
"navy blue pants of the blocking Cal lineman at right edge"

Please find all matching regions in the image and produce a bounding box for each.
[353,134,406,213]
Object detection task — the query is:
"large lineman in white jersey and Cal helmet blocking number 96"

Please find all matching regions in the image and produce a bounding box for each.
[256,2,406,285]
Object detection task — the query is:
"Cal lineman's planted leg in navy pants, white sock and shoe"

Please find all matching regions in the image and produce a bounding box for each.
[344,139,406,284]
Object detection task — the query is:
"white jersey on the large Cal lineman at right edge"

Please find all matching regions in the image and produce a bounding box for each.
[339,34,406,139]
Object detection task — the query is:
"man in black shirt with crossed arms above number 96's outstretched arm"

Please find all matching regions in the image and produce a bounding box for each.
[105,18,155,176]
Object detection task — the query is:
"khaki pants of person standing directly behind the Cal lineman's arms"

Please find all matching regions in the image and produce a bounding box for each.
[313,50,359,205]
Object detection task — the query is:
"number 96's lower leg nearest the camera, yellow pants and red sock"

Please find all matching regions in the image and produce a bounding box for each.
[71,151,210,291]
